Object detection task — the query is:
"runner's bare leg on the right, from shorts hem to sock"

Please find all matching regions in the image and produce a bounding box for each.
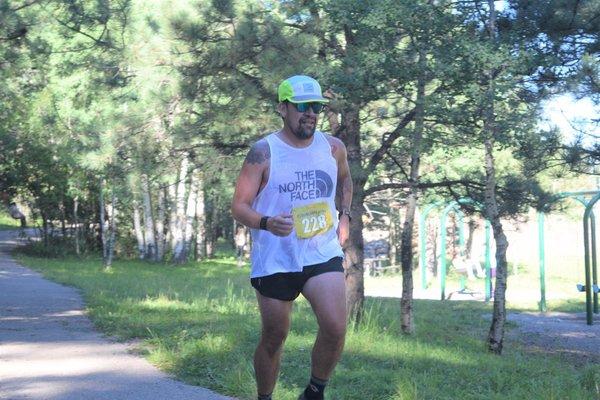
[302,272,346,398]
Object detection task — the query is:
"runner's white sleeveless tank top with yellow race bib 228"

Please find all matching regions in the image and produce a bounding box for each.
[250,131,344,278]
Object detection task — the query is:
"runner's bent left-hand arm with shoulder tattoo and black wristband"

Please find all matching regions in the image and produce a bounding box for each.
[231,139,293,236]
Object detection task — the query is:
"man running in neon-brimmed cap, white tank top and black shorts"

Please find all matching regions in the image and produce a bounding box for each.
[231,75,352,400]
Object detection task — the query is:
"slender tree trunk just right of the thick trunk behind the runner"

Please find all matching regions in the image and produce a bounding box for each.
[400,47,426,334]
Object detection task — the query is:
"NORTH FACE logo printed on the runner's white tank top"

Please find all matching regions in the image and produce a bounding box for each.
[279,169,333,201]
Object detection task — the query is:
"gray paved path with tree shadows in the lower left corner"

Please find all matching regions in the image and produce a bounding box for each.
[0,231,234,400]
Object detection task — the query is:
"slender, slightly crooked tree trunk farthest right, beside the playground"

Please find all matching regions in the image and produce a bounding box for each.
[484,0,508,355]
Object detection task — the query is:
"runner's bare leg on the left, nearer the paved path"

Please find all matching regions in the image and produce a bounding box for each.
[254,292,292,395]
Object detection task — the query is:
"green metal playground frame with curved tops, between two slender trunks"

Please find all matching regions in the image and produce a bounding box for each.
[419,198,492,301]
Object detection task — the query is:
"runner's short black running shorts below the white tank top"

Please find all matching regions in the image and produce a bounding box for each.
[250,257,344,301]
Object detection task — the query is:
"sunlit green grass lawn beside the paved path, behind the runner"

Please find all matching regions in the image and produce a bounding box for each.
[19,256,600,400]
